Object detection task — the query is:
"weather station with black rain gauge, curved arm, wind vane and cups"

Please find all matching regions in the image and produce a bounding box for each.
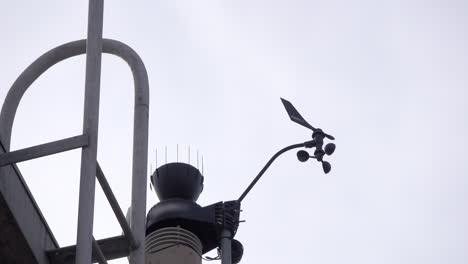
[145,99,335,264]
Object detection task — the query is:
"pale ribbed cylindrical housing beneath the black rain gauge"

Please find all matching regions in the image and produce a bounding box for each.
[145,227,202,264]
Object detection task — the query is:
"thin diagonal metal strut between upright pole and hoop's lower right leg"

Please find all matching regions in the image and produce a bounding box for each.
[96,163,138,249]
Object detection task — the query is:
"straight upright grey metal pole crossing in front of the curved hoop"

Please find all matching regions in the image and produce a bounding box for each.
[76,0,104,264]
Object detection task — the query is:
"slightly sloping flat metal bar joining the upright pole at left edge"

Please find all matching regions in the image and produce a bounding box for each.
[0,134,88,167]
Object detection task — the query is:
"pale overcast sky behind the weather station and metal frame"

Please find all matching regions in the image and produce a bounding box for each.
[0,0,468,264]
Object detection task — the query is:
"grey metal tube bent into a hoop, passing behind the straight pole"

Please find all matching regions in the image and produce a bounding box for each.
[0,39,149,260]
